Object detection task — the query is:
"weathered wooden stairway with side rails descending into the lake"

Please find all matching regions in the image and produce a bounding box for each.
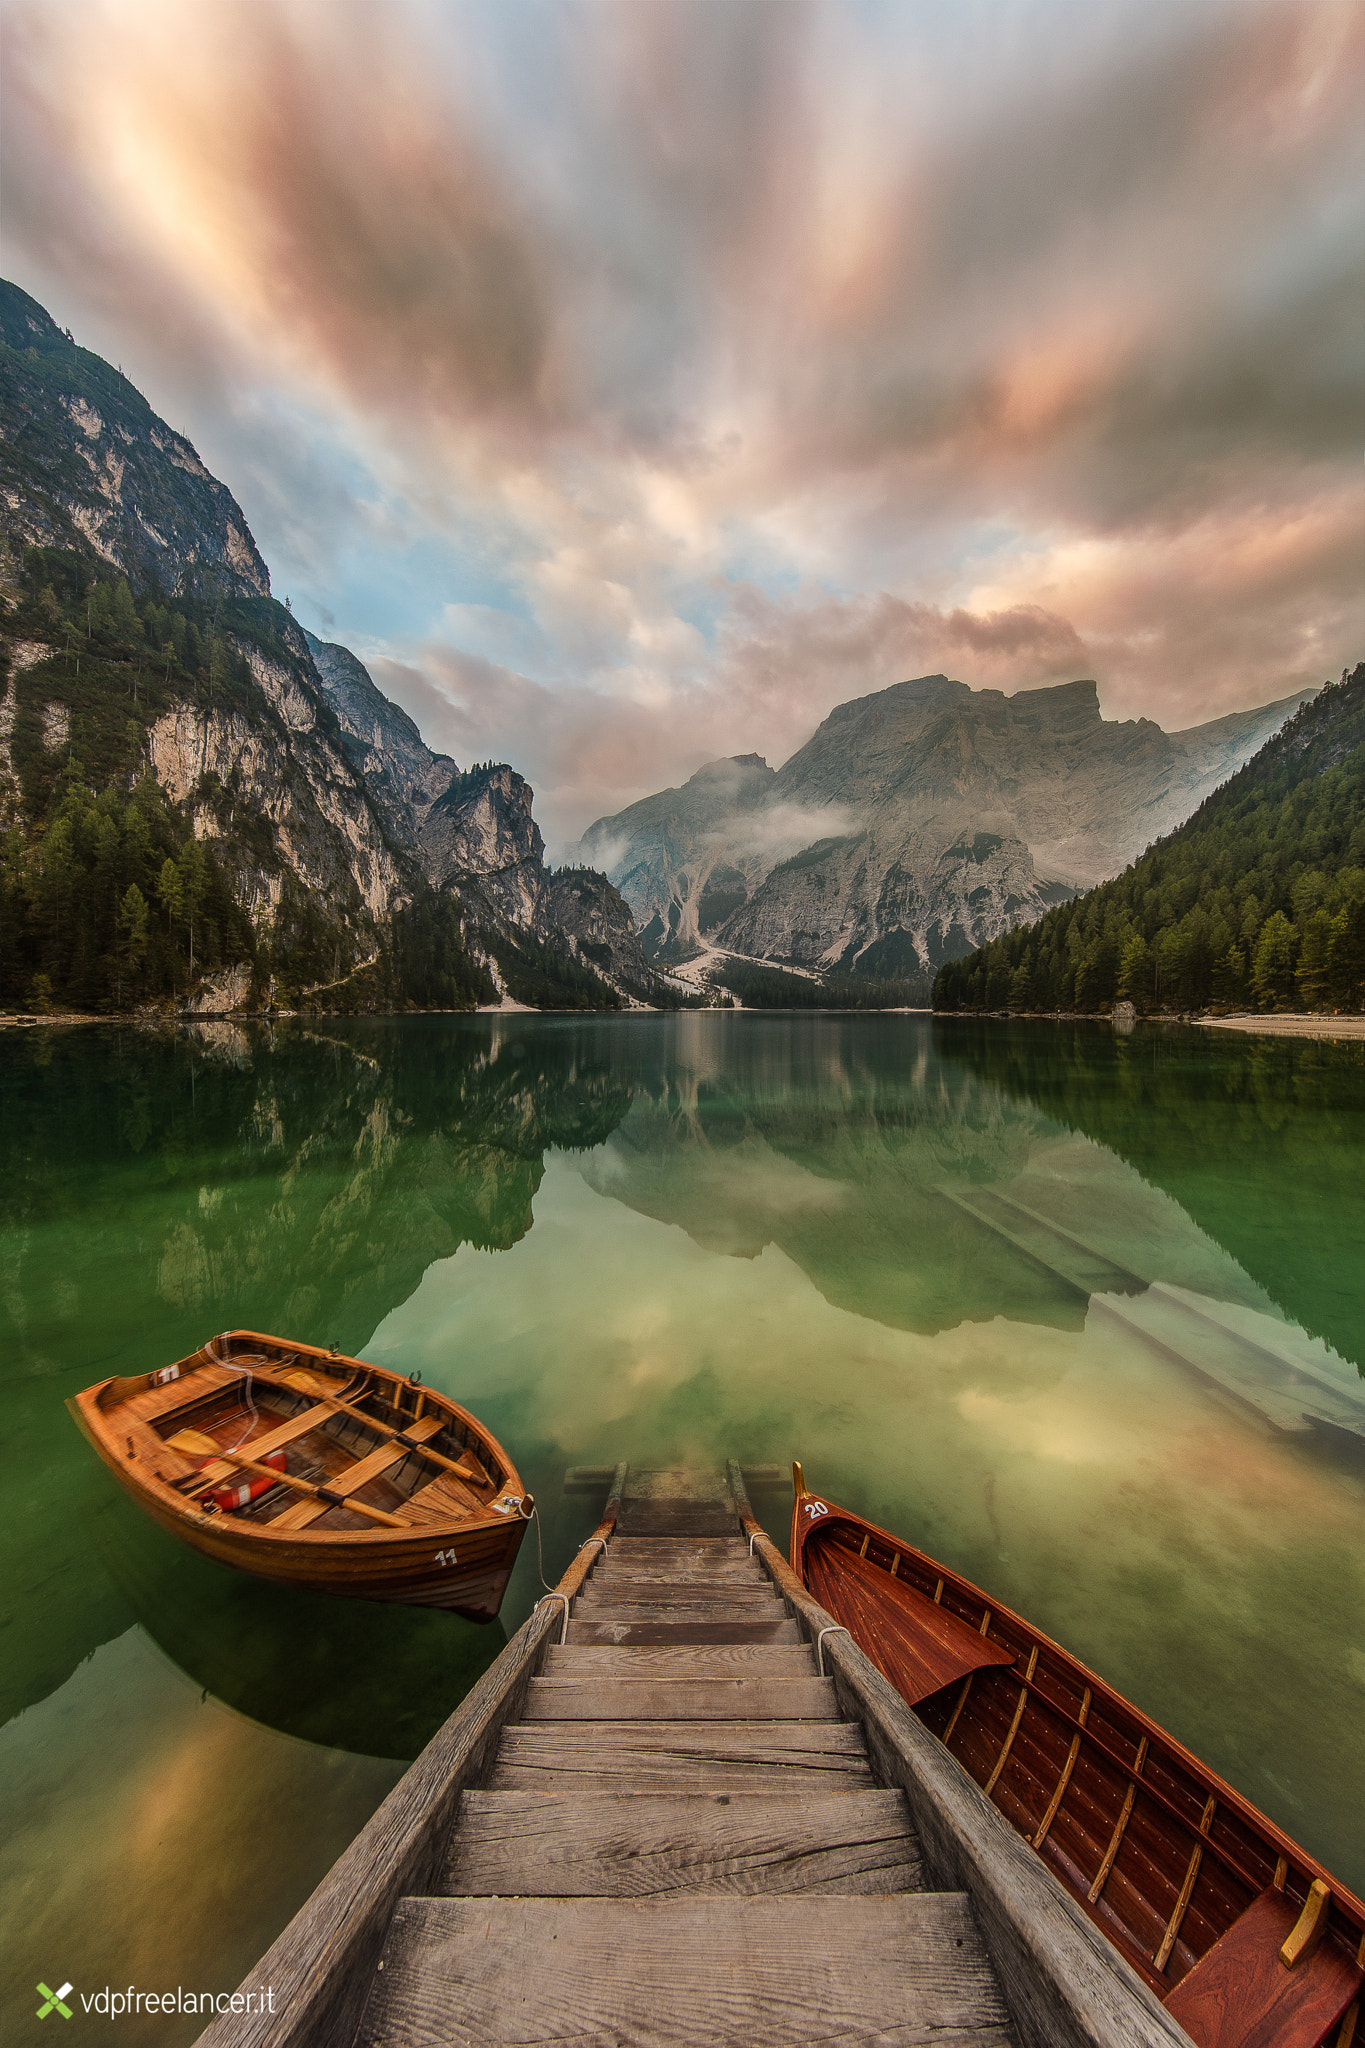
[201,1466,1187,2048]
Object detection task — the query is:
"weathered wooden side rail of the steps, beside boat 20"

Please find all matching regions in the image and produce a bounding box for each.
[729,1464,1191,2048]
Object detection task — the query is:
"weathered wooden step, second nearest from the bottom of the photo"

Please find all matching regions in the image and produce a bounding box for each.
[432,1792,925,1898]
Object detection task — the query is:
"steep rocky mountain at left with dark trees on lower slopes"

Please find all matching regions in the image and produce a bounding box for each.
[0,285,655,1008]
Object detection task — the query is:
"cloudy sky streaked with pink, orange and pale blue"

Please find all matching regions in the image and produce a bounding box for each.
[0,0,1365,852]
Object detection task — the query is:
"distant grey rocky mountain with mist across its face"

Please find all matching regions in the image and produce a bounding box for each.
[579,676,1304,975]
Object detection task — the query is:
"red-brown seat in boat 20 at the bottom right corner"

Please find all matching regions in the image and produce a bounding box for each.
[1166,1888,1365,2048]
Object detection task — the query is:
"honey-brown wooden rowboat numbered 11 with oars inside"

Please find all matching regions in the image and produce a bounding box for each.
[68,1329,534,1622]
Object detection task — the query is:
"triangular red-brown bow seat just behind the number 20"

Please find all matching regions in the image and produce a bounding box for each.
[806,1542,1015,1706]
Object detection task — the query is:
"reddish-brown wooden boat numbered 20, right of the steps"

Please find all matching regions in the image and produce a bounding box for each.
[792,1464,1365,2048]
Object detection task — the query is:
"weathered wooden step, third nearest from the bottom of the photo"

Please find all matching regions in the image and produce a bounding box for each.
[497,1720,872,1792]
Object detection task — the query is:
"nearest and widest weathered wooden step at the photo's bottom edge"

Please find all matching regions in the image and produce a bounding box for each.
[356,1892,1011,2048]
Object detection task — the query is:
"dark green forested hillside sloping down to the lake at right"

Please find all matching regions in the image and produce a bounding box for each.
[933,664,1365,1012]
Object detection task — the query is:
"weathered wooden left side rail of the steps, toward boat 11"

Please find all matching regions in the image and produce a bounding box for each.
[196,1464,626,2048]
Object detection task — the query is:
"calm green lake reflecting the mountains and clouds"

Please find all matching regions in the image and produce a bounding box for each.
[0,1012,1365,2048]
